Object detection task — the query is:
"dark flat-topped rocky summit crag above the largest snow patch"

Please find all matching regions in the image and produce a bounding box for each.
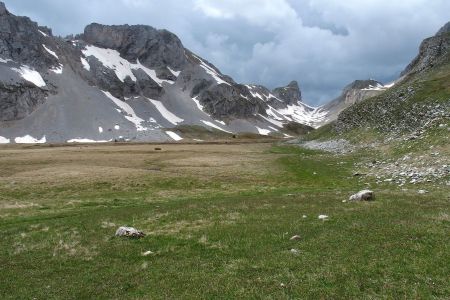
[81,23,186,70]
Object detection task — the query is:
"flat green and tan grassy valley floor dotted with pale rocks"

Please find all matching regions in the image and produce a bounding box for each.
[0,143,450,299]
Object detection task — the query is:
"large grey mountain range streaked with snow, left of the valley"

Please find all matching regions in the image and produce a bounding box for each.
[0,2,326,143]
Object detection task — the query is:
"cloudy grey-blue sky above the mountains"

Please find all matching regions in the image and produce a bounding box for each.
[3,0,450,105]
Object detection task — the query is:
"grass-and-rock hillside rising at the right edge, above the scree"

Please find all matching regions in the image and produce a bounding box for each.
[333,23,450,136]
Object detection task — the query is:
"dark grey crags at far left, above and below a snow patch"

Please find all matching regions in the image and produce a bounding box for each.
[0,2,59,121]
